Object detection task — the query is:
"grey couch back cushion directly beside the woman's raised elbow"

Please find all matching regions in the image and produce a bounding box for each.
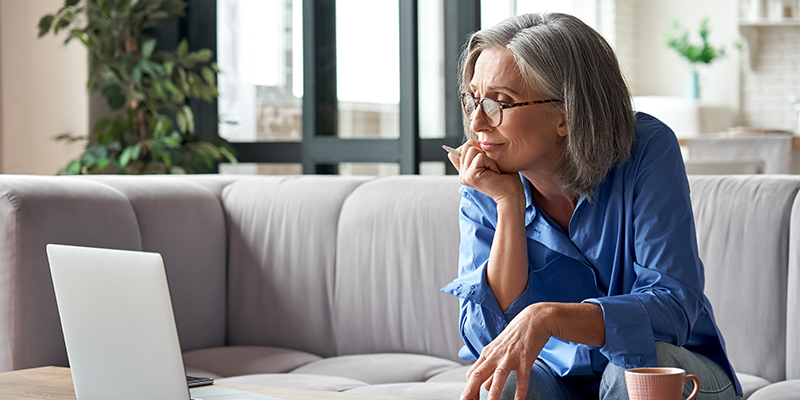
[333,176,463,360]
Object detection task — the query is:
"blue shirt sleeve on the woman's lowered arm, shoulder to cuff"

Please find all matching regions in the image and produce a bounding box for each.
[585,124,705,368]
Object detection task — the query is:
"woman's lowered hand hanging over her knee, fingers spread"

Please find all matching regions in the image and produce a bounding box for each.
[461,303,552,400]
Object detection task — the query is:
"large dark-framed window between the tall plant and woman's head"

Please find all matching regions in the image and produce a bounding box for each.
[180,0,480,175]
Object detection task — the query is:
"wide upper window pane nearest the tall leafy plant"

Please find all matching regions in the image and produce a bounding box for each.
[217,0,303,142]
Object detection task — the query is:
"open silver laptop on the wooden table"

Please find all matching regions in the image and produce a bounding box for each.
[47,244,279,400]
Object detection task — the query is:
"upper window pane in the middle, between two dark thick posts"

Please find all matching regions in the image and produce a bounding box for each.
[336,0,400,138]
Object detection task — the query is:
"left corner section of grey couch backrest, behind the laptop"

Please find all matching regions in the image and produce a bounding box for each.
[0,175,230,371]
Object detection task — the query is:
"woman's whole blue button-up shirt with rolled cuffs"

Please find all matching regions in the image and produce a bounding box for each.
[442,113,741,395]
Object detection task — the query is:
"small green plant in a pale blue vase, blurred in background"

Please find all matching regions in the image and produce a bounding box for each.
[663,18,725,99]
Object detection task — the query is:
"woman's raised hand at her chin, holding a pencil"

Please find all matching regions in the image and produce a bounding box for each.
[447,140,524,203]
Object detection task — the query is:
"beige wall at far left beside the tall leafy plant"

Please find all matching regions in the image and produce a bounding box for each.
[0,0,89,175]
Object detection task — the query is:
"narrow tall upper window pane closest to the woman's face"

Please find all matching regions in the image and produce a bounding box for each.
[417,0,444,138]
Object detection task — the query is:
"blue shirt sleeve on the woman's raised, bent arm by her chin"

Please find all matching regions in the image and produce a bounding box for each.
[441,187,528,359]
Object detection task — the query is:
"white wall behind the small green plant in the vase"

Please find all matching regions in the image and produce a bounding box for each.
[629,0,741,122]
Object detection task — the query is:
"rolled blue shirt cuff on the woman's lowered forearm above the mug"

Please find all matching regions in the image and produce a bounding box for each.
[583,295,658,369]
